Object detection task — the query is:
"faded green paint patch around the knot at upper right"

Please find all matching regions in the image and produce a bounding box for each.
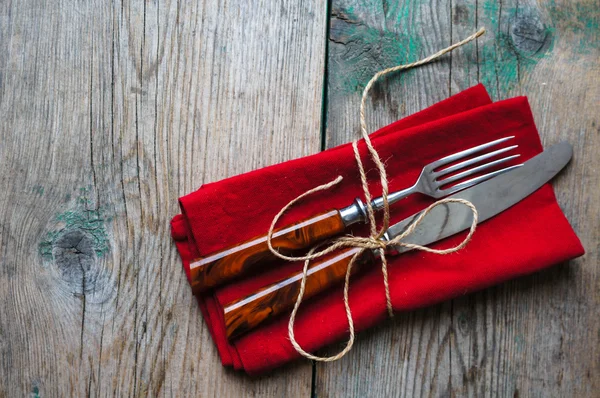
[479,0,600,99]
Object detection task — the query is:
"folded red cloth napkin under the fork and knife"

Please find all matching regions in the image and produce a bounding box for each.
[172,85,584,374]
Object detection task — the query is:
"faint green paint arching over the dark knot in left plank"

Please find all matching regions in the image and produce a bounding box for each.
[39,188,110,260]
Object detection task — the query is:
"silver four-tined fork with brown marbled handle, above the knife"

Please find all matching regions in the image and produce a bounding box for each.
[190,136,521,294]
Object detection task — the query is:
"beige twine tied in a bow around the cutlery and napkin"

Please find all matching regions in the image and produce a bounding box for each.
[267,28,485,362]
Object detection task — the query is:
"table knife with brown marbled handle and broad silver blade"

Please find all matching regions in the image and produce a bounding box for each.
[224,142,573,340]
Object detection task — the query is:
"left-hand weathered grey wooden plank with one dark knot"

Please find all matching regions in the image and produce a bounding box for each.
[0,0,326,397]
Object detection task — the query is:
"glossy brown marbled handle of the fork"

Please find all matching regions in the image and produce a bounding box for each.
[190,210,345,294]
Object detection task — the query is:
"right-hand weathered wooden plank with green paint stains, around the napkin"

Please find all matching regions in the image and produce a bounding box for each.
[315,0,600,397]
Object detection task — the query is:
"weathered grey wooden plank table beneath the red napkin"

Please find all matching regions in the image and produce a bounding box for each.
[0,0,600,397]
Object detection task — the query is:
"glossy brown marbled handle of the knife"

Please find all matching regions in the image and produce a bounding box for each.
[223,248,373,340]
